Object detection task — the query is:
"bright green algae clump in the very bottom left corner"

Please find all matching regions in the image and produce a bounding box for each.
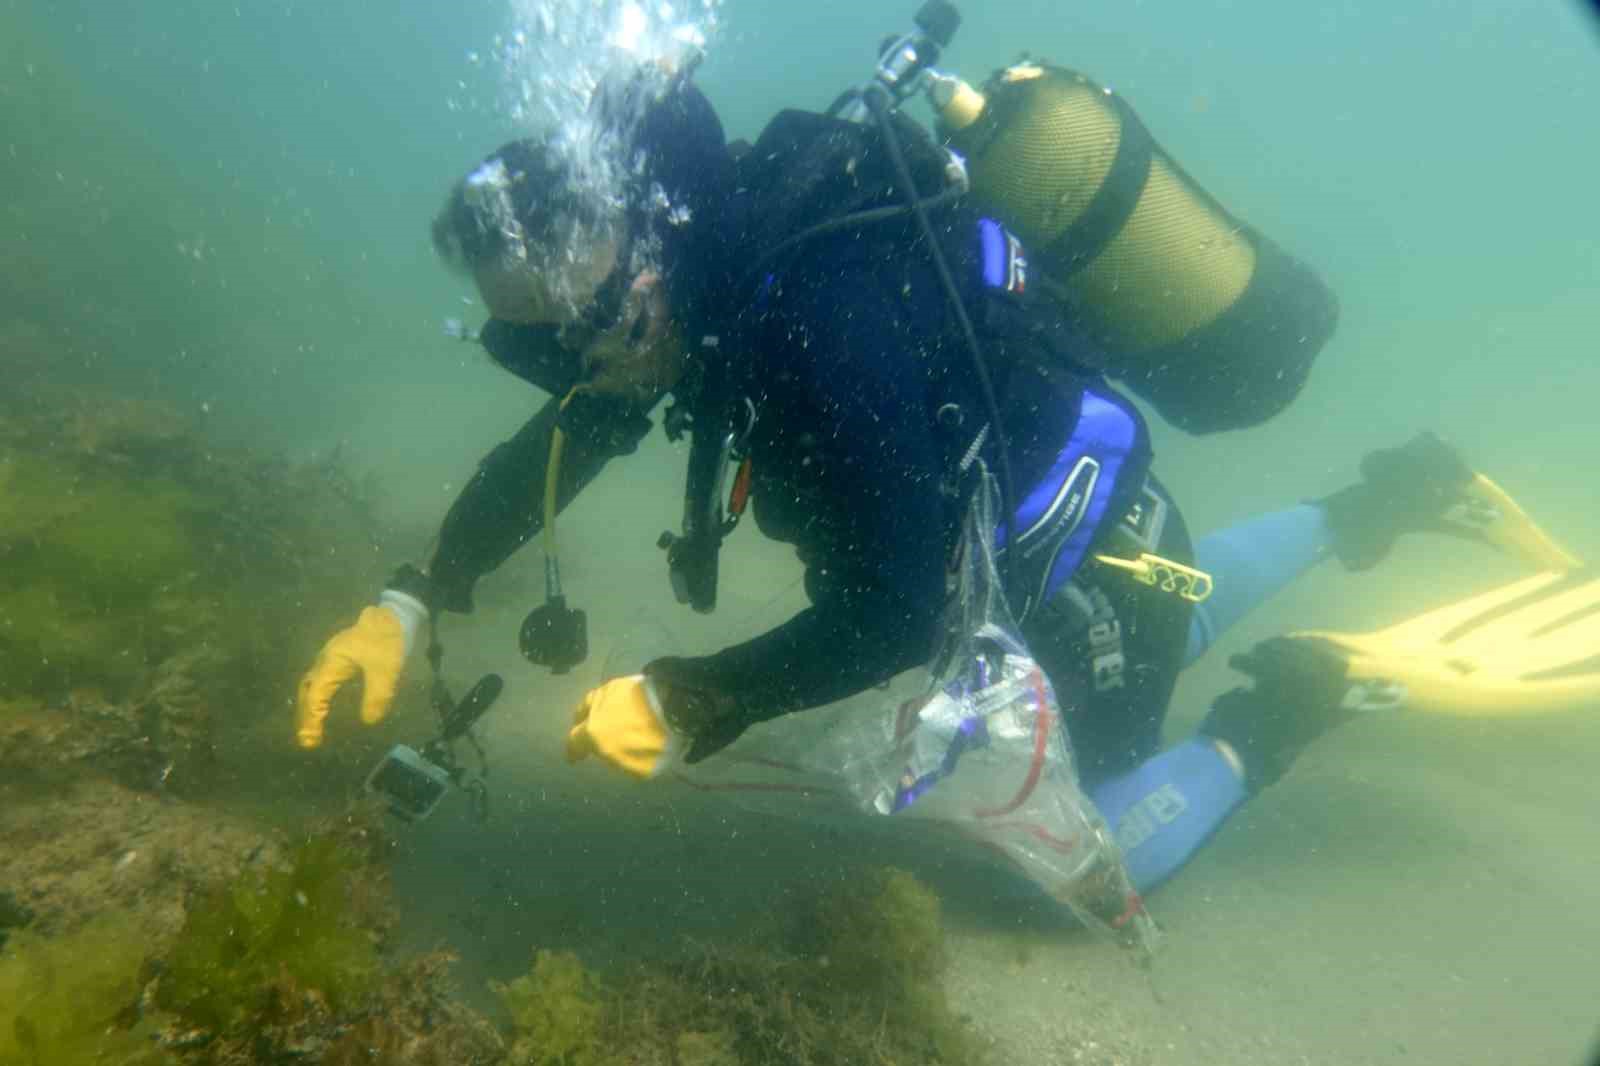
[0,917,174,1066]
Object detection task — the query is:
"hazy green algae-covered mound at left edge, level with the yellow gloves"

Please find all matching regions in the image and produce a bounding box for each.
[0,377,381,792]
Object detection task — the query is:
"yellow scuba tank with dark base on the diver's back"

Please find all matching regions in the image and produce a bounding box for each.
[928,62,1338,434]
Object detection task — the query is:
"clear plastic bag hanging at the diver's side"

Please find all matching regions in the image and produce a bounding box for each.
[685,479,1160,954]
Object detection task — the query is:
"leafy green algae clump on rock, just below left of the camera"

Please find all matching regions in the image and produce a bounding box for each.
[157,837,378,1032]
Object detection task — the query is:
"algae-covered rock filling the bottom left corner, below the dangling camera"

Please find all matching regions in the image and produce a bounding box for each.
[0,778,504,1066]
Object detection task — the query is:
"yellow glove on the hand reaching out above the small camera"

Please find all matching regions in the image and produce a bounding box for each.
[294,603,408,749]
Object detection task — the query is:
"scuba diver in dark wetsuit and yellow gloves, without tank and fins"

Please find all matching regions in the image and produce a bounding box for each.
[296,12,1587,892]
